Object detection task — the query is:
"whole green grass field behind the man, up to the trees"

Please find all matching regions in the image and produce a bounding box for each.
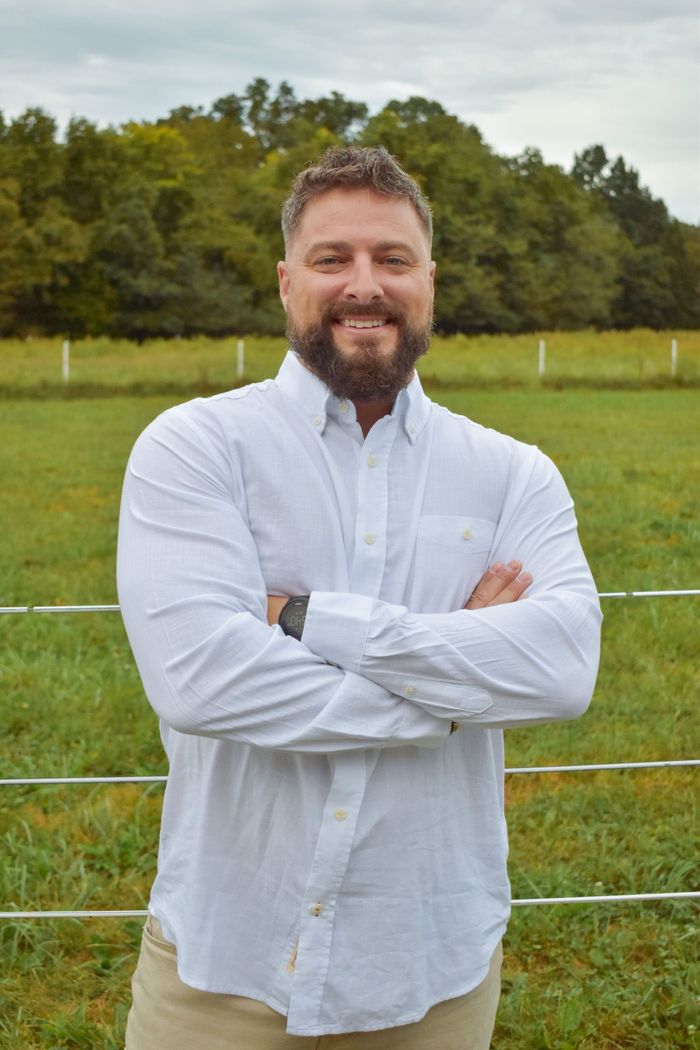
[0,333,700,1050]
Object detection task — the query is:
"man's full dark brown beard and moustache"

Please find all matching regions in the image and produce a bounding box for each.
[287,302,432,401]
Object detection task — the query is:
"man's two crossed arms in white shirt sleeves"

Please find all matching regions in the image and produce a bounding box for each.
[118,411,600,752]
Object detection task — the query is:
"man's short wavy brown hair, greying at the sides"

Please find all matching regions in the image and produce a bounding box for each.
[282,146,432,247]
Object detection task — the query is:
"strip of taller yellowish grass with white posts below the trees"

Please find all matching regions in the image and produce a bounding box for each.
[0,329,700,400]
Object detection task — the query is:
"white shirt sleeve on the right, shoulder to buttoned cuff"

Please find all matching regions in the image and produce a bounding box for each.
[303,449,602,729]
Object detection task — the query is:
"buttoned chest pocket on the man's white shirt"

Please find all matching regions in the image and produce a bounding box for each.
[410,515,496,612]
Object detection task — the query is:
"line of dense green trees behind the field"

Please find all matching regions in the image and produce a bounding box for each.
[0,79,700,339]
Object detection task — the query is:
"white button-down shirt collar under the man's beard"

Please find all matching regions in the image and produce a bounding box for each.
[276,350,430,444]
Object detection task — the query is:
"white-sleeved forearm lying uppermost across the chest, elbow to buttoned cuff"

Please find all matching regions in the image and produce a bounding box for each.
[304,593,600,728]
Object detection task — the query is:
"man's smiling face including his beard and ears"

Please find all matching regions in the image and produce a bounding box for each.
[277,189,434,401]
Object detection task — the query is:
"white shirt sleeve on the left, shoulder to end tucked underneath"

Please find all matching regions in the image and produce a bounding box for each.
[118,412,449,752]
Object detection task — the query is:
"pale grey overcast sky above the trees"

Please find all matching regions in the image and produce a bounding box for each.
[0,0,700,223]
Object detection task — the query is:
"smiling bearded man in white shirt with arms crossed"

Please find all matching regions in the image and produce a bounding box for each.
[119,147,600,1050]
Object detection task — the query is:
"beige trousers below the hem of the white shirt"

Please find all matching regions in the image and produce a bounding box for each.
[126,918,503,1050]
